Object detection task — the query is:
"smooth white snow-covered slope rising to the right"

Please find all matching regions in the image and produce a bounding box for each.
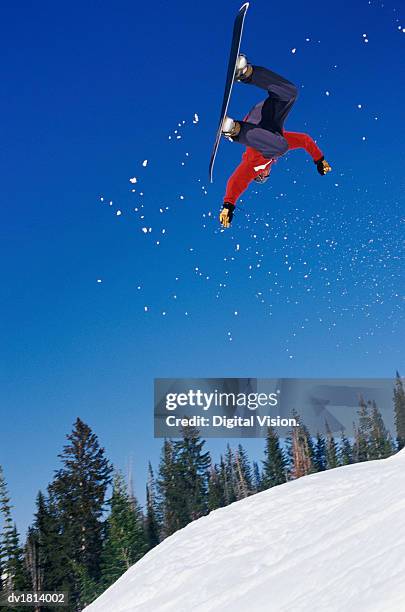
[86,451,405,612]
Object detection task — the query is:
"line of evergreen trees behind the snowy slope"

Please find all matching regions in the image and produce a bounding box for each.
[0,374,405,612]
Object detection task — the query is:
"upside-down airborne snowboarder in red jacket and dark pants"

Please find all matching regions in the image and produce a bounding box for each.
[219,54,332,227]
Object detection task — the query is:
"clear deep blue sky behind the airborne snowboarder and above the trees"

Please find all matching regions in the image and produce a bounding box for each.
[0,0,405,530]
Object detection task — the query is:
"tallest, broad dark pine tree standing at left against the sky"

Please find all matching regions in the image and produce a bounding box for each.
[49,418,112,605]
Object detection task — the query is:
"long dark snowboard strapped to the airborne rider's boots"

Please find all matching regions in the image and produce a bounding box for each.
[209,2,249,183]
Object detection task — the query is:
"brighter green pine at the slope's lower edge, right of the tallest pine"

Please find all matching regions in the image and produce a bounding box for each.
[100,473,147,589]
